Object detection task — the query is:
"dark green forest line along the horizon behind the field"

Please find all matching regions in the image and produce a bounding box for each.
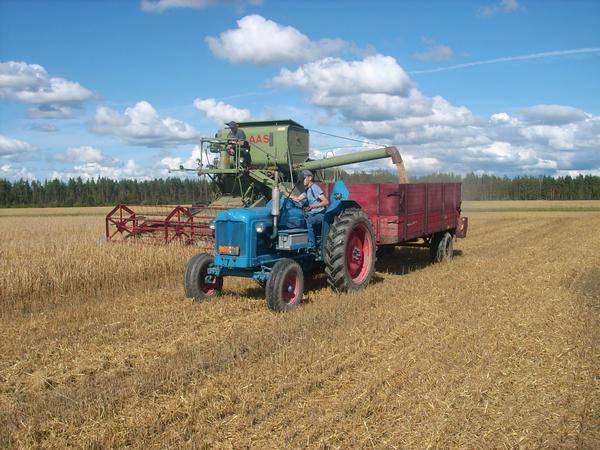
[0,170,600,207]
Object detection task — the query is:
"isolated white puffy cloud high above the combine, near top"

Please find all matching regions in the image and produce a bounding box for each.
[206,14,348,66]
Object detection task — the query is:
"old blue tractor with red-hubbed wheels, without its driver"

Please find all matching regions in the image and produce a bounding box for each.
[184,181,377,311]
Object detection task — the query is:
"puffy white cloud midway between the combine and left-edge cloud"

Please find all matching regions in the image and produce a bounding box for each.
[92,101,198,147]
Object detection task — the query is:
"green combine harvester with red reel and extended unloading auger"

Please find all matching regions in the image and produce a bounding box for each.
[106,120,408,249]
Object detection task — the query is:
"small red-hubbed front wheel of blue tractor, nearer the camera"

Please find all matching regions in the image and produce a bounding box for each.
[265,258,304,312]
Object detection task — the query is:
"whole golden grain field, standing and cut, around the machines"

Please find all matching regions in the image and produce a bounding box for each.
[0,202,600,448]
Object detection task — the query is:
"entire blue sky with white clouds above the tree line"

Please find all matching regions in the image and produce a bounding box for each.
[0,0,600,179]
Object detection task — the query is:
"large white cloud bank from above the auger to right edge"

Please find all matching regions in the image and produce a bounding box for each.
[271,49,600,175]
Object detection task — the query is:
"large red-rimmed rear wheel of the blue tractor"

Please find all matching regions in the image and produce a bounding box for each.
[324,209,377,292]
